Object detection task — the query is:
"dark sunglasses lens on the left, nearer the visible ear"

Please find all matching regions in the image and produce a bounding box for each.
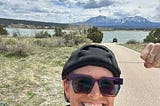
[72,77,93,93]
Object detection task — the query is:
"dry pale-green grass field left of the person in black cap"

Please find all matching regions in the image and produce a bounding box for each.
[0,36,76,106]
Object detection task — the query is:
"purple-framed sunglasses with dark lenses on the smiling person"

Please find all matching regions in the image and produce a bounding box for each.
[69,73,123,97]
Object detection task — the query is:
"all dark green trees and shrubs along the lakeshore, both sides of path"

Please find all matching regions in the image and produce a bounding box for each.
[0,25,160,43]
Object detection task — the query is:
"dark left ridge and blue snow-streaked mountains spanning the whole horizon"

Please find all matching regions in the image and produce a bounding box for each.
[0,15,160,29]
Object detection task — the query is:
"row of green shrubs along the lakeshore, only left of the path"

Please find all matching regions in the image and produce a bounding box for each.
[0,25,103,43]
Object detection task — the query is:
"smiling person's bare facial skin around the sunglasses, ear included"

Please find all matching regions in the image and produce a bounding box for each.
[64,66,114,106]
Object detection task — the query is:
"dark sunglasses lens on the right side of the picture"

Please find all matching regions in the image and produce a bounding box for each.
[99,79,117,96]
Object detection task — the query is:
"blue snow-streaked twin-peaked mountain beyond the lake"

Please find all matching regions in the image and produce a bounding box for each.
[76,16,160,28]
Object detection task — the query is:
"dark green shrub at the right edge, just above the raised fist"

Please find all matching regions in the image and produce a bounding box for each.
[144,28,160,43]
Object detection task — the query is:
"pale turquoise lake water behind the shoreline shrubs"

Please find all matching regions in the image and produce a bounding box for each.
[6,28,149,43]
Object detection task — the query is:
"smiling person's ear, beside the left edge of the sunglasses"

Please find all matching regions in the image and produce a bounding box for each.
[63,79,70,101]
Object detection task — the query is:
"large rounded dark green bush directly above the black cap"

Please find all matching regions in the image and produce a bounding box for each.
[87,26,103,43]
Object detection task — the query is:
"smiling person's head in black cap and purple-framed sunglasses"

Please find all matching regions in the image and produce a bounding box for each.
[62,45,123,106]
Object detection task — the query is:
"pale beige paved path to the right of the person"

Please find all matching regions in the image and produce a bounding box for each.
[102,43,160,106]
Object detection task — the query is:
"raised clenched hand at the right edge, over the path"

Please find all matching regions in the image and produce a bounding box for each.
[141,43,160,68]
